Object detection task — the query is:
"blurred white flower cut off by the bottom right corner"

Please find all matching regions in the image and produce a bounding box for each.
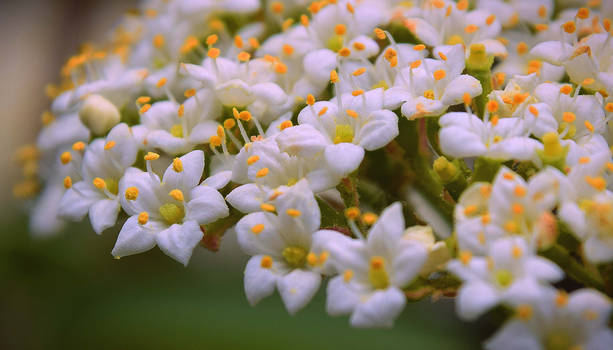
[485,288,613,350]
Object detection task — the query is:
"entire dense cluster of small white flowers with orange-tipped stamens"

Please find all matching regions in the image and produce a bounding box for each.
[15,0,613,349]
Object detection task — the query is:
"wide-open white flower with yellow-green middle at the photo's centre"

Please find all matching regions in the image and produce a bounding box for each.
[276,89,398,177]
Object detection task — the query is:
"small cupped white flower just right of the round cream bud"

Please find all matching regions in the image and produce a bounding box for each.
[141,90,221,154]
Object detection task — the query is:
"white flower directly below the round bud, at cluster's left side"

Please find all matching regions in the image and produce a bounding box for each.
[59,123,138,234]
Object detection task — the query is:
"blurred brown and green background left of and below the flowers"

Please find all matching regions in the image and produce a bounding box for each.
[0,0,486,350]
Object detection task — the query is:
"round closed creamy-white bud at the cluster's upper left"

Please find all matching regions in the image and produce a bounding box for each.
[79,95,121,135]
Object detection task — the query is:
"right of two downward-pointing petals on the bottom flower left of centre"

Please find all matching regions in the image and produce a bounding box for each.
[277,269,321,314]
